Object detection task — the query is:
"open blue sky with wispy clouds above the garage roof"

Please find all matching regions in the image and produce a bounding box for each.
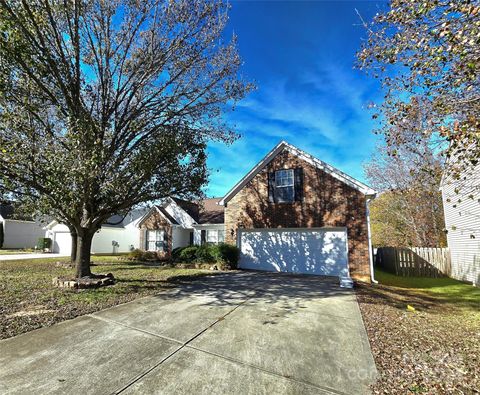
[206,0,381,196]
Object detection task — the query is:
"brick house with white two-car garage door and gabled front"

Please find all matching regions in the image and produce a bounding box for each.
[135,142,375,282]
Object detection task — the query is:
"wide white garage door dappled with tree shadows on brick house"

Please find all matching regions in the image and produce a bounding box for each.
[239,228,349,276]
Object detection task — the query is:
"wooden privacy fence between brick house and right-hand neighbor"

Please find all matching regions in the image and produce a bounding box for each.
[375,247,451,277]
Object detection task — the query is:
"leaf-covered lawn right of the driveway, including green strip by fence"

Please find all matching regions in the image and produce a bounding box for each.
[357,270,480,394]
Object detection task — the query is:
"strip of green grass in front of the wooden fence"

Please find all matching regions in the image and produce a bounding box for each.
[375,269,480,311]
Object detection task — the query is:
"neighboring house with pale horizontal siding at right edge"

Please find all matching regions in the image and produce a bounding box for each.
[441,164,480,286]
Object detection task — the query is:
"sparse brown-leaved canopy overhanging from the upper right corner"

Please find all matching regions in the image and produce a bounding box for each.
[358,0,480,171]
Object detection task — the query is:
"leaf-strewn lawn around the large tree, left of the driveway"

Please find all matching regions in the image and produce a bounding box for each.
[0,256,212,338]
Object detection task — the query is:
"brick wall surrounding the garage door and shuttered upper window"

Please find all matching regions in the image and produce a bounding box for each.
[225,151,370,282]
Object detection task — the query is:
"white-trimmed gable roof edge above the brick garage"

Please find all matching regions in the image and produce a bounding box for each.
[219,141,376,205]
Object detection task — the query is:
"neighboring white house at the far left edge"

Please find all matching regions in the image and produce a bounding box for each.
[0,203,44,249]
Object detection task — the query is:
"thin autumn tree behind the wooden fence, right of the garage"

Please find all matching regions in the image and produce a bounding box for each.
[365,141,446,247]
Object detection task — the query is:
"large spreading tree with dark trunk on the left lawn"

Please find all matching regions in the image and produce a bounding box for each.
[0,0,252,277]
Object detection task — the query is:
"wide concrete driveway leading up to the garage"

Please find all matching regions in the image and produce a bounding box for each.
[0,272,376,394]
